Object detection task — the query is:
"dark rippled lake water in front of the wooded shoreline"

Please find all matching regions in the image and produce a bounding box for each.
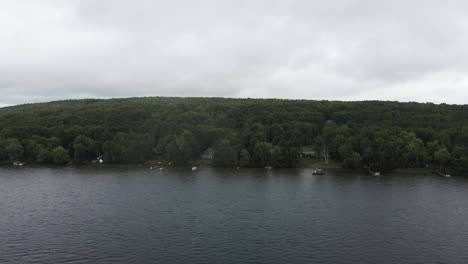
[0,166,468,264]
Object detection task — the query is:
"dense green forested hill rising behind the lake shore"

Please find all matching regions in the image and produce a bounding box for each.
[0,97,468,172]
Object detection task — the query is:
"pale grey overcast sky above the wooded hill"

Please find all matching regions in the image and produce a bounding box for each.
[0,0,468,106]
